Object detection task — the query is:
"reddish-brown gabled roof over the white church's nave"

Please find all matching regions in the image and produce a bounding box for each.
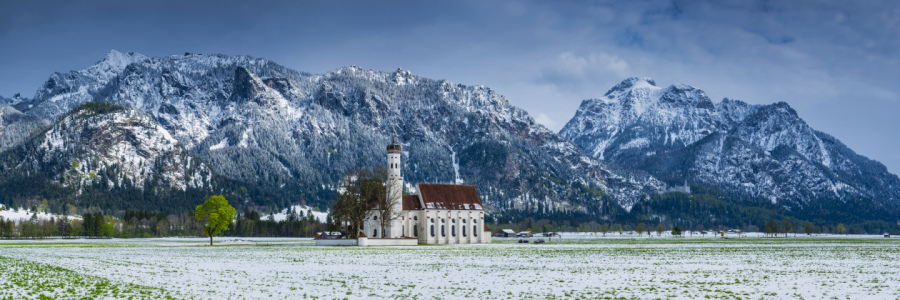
[418,183,484,210]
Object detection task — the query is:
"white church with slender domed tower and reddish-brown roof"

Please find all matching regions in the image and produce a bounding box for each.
[363,139,491,244]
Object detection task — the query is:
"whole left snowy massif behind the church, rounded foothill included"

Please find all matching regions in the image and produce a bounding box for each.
[0,51,665,215]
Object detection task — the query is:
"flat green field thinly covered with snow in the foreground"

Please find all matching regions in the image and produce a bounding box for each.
[0,235,900,299]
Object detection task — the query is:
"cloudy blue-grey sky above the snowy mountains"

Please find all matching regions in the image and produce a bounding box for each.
[0,0,900,173]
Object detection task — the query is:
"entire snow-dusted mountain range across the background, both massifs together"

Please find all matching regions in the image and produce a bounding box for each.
[0,51,900,220]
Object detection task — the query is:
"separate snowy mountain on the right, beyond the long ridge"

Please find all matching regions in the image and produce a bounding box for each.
[560,78,900,219]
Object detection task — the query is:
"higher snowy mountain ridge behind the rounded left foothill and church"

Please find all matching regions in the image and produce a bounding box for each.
[1,51,665,214]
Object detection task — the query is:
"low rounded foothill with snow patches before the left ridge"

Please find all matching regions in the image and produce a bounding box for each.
[21,103,212,190]
